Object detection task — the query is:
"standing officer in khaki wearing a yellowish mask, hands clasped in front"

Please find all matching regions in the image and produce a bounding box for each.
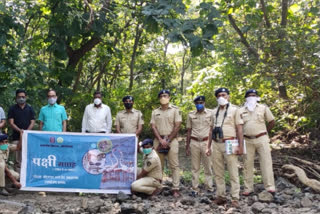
[150,90,182,197]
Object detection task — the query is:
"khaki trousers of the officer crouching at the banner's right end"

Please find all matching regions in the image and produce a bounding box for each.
[131,168,162,195]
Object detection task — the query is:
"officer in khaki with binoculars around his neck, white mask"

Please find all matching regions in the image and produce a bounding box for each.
[207,88,243,207]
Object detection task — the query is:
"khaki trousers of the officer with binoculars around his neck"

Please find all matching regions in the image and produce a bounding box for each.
[212,142,240,200]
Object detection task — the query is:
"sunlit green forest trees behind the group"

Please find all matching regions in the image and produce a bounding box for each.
[0,0,320,140]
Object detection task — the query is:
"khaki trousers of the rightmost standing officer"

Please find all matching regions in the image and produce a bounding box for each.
[243,135,275,192]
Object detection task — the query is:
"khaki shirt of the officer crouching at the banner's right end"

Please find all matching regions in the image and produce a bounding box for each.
[143,150,162,180]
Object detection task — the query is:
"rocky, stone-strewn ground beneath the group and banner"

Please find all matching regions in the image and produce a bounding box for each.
[0,138,320,214]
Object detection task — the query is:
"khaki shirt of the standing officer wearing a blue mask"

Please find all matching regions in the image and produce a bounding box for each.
[187,108,212,138]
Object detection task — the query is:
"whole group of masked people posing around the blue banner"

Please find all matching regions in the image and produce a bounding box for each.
[0,88,275,206]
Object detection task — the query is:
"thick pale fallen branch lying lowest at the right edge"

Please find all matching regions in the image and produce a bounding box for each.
[282,164,320,192]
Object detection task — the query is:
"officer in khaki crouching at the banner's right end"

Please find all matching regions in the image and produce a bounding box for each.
[131,139,162,195]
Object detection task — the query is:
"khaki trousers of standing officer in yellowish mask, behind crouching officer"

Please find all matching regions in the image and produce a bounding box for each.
[154,138,180,190]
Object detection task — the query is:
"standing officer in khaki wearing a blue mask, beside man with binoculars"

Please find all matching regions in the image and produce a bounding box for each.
[186,96,213,192]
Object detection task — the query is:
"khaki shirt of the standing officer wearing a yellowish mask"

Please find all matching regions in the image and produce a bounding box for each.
[150,104,182,136]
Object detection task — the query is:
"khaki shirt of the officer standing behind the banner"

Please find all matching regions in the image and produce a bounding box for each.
[115,109,144,133]
